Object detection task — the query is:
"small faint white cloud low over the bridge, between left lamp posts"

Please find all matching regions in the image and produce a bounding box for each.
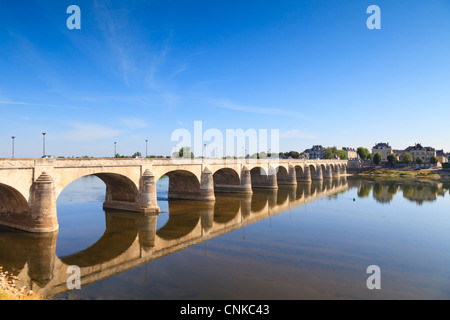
[64,123,121,141]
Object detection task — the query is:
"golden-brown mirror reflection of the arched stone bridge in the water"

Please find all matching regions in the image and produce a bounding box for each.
[0,177,348,297]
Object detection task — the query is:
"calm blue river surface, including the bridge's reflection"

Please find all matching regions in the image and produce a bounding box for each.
[0,176,450,299]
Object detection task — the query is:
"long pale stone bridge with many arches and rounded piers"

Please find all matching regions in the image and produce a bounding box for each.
[0,158,347,233]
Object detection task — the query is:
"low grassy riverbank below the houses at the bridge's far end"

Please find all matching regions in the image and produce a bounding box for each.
[353,167,450,182]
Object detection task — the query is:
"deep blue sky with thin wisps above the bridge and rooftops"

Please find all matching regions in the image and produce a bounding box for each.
[0,0,450,157]
